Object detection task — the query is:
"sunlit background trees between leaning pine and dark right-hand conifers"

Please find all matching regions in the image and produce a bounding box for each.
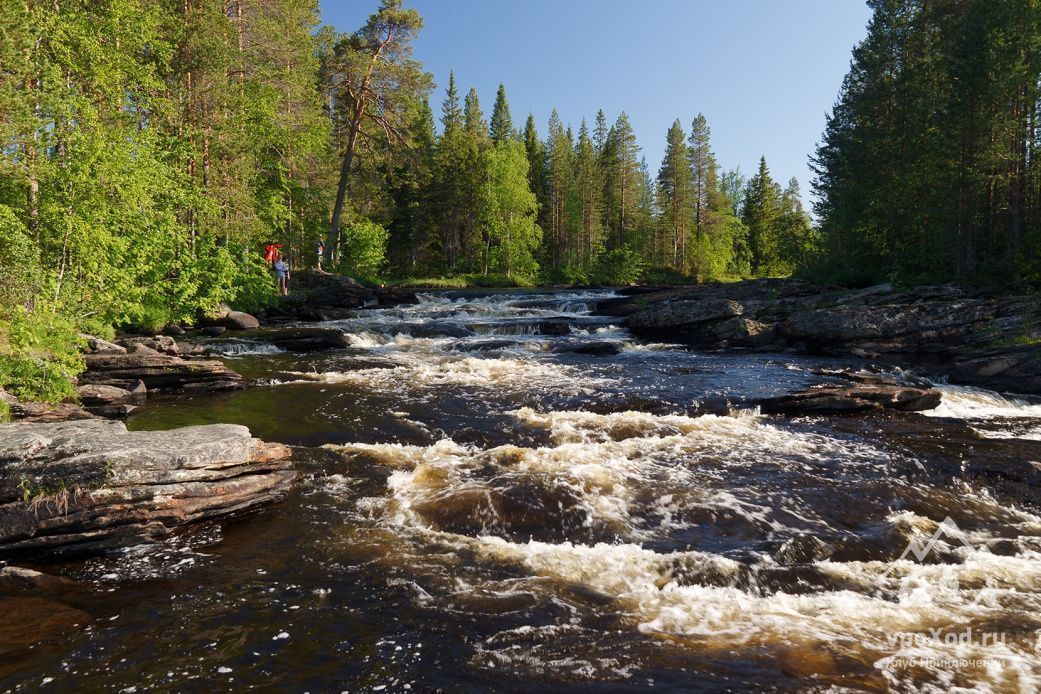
[366,71,813,284]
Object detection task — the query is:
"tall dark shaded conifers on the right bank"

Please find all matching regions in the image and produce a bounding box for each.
[807,0,1041,289]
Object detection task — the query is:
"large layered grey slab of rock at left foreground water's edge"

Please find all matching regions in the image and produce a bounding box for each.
[0,419,295,555]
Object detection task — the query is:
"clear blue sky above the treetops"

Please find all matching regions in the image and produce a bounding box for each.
[321,0,869,200]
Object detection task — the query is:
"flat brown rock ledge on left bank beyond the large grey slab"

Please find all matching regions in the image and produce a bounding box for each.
[80,343,245,391]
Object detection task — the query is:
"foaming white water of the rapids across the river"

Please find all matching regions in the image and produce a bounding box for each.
[301,297,1041,691]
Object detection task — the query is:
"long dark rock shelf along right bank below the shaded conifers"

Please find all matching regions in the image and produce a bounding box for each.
[599,280,1041,393]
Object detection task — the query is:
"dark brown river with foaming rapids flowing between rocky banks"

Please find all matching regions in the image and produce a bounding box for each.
[0,293,1041,691]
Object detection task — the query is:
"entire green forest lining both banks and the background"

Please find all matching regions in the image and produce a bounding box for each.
[0,0,1041,399]
